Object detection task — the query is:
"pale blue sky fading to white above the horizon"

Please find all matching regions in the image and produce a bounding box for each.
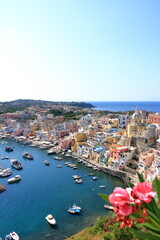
[0,0,160,101]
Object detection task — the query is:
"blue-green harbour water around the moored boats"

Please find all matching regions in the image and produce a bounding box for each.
[0,140,123,240]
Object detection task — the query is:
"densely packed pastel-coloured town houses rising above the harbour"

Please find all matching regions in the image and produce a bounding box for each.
[0,103,160,184]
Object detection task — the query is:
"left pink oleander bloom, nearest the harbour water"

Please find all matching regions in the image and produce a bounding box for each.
[109,187,131,207]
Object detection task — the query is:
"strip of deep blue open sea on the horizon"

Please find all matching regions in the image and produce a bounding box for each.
[89,101,160,112]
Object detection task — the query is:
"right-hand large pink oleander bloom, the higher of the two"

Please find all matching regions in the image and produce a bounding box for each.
[132,182,156,203]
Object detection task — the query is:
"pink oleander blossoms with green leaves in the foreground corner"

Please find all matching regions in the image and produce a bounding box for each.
[99,174,160,240]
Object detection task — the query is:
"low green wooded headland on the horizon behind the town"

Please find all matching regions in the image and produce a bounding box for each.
[0,99,94,114]
